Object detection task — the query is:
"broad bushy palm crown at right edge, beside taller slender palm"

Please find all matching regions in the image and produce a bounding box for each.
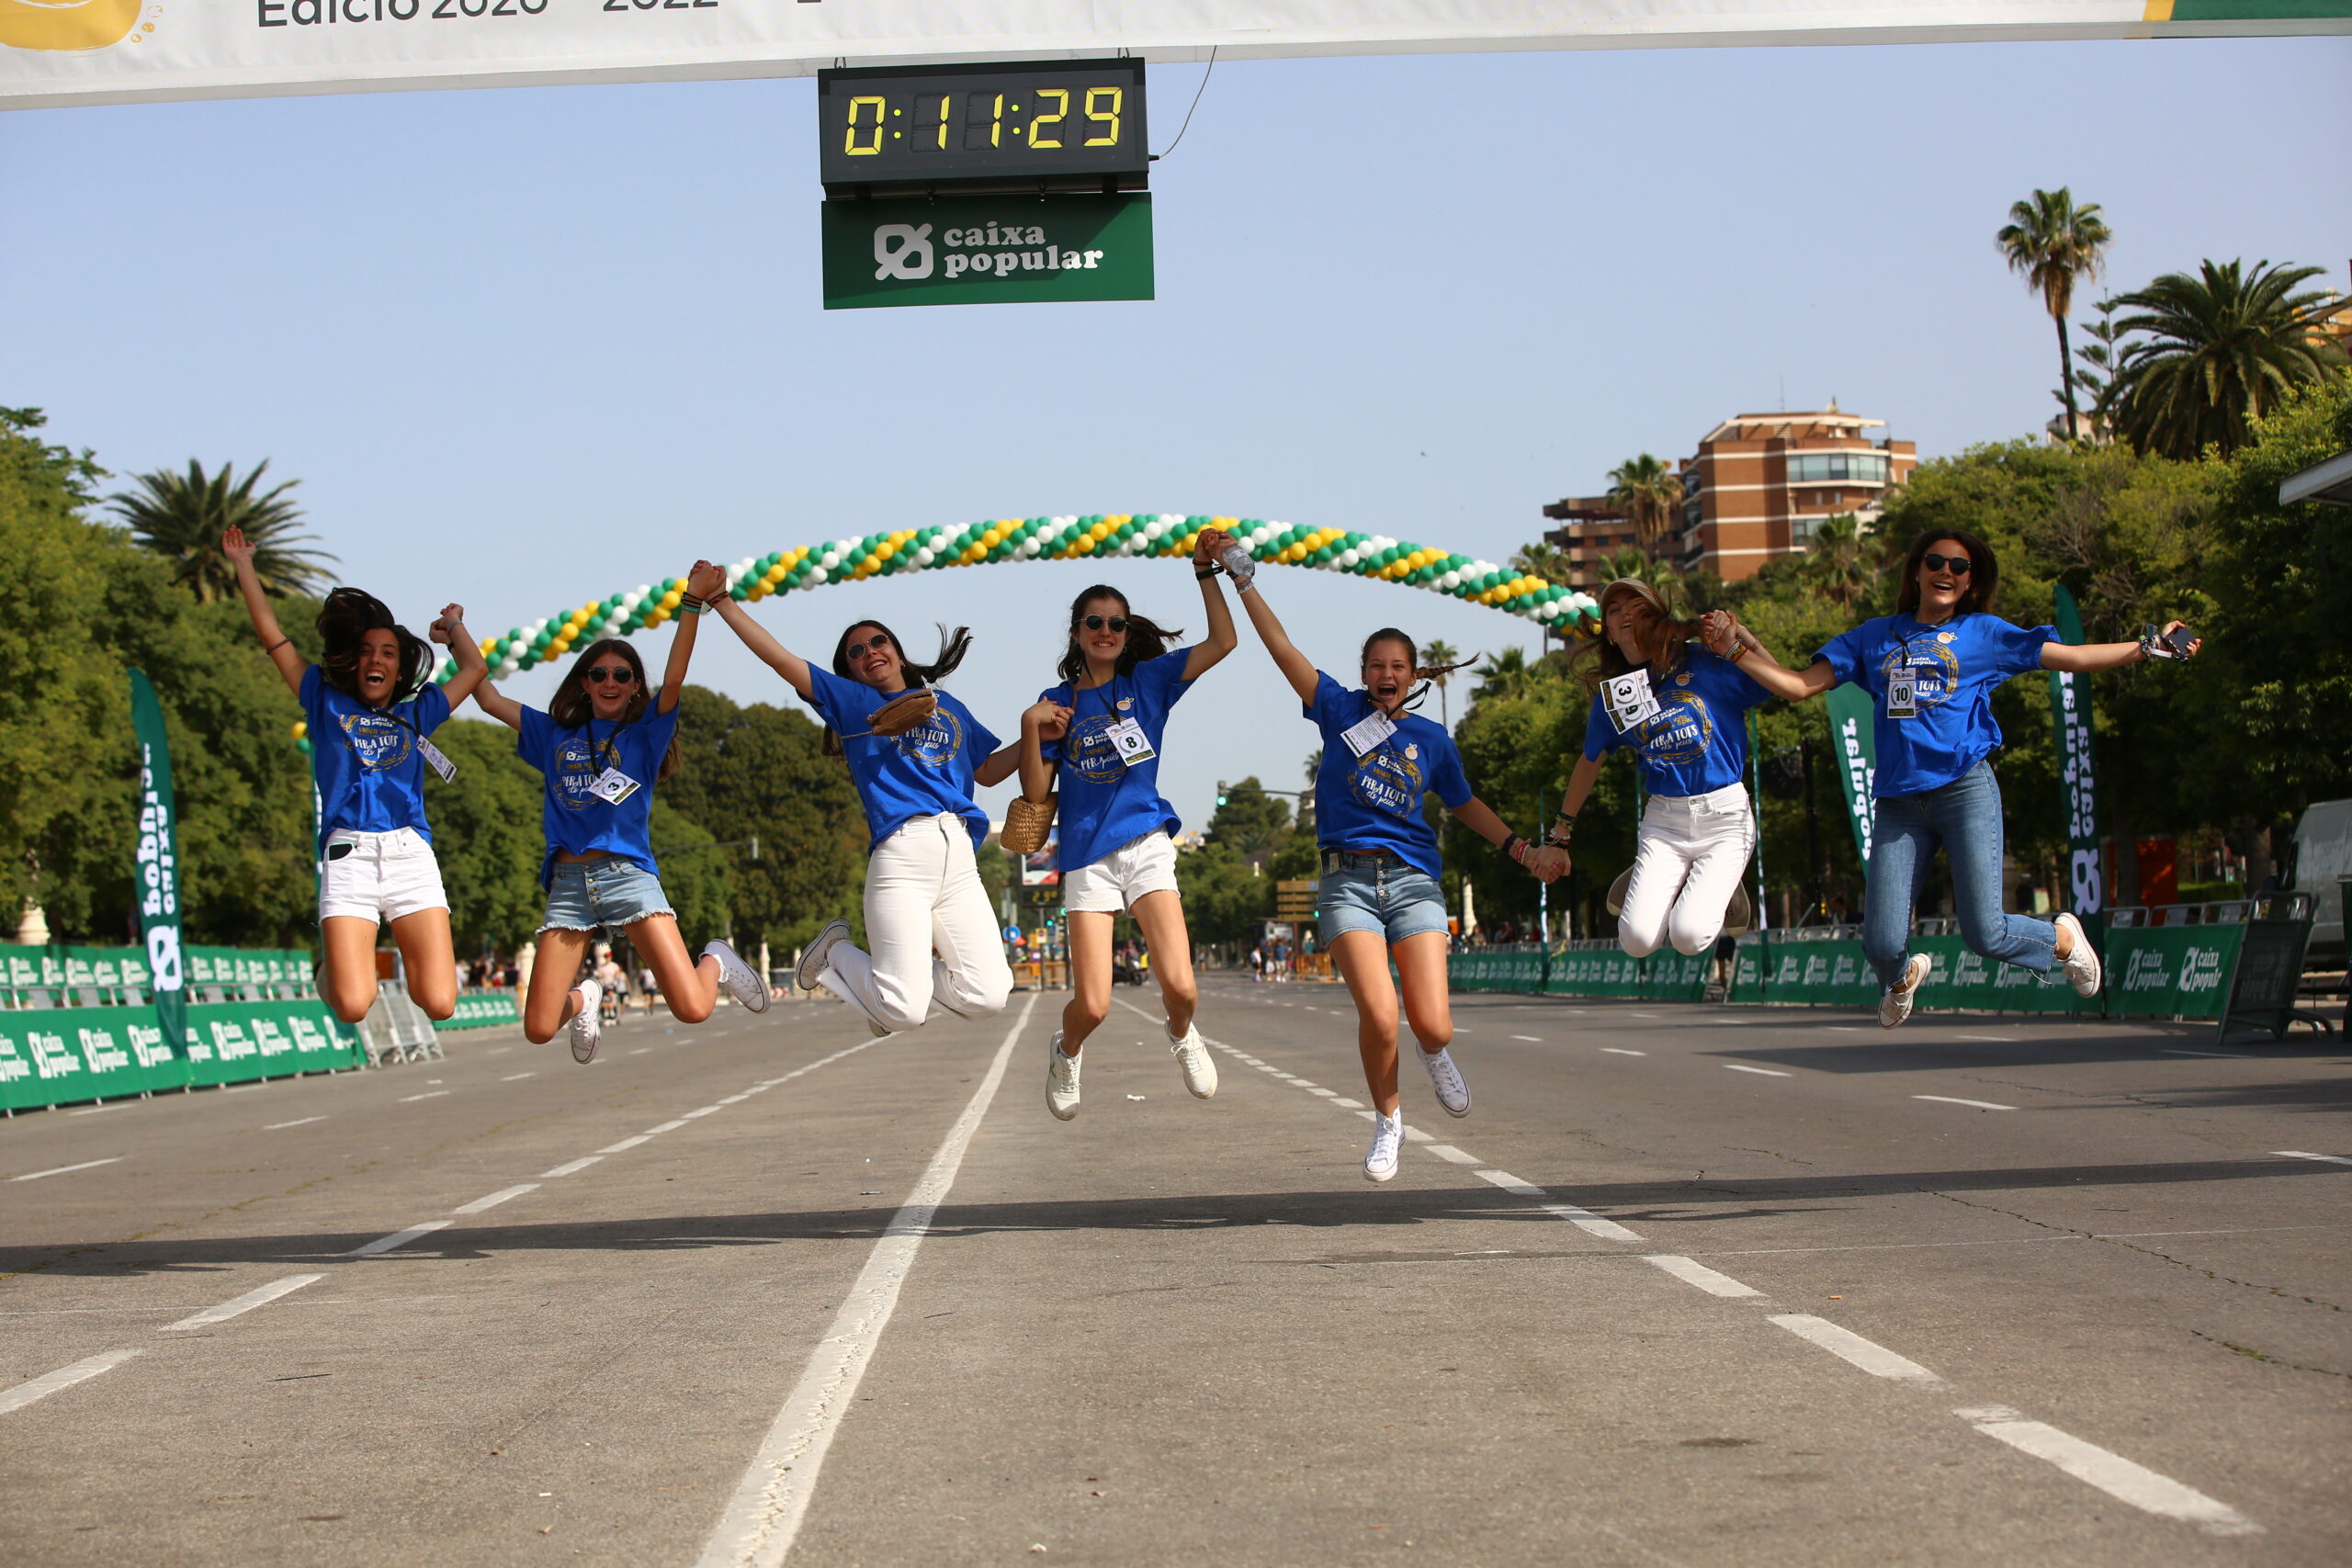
[2117,261,2345,458]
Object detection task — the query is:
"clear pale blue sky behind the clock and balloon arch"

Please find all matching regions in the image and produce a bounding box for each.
[0,38,2352,841]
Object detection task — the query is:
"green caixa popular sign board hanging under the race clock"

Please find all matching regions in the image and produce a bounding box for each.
[823,190,1152,310]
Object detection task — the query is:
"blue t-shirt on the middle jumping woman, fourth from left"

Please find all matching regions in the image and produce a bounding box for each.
[1037,649,1193,872]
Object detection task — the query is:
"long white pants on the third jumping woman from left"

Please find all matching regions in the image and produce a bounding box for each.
[819,811,1013,1034]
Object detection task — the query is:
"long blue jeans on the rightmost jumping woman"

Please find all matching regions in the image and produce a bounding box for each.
[1863,761,2058,989]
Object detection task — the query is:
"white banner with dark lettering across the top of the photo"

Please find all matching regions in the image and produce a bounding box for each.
[0,0,2352,108]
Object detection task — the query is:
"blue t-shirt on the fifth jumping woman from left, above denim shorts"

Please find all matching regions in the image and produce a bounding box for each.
[1301,670,1470,877]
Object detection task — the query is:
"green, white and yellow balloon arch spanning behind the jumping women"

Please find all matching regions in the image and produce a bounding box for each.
[435,513,1600,680]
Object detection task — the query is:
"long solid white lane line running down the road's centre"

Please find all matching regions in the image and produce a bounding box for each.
[698,992,1037,1568]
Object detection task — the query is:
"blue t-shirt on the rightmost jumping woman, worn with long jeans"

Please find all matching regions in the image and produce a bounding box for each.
[1815,614,2058,799]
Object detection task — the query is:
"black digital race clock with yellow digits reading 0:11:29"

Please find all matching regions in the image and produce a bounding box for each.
[816,59,1150,197]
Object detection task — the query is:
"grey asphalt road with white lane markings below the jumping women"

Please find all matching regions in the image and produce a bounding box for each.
[0,980,2352,1568]
